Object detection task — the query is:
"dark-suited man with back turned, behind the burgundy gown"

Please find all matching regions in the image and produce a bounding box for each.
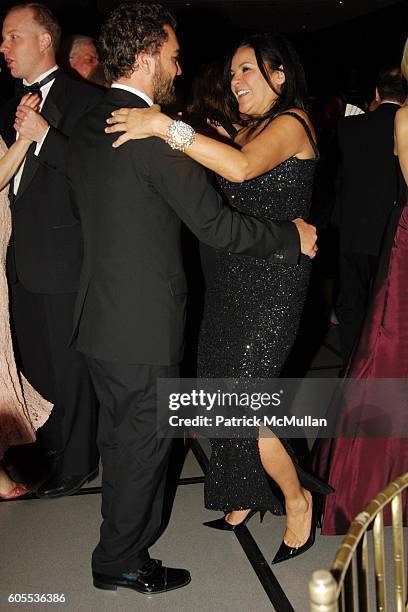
[336,69,407,363]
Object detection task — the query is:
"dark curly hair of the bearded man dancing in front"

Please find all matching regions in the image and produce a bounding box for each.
[99,2,176,81]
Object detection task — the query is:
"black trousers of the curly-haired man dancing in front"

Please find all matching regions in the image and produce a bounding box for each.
[87,357,179,575]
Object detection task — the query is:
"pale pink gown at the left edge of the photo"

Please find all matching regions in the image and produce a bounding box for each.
[0,138,52,459]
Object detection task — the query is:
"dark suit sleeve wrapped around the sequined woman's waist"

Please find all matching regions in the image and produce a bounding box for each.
[143,138,300,264]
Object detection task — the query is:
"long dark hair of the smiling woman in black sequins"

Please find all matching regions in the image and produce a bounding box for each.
[224,33,307,128]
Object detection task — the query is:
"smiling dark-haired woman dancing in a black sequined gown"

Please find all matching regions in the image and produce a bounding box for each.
[105,35,328,560]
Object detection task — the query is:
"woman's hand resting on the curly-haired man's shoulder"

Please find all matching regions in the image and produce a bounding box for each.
[105,104,165,147]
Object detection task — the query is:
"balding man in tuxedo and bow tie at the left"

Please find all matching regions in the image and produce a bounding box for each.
[0,3,103,497]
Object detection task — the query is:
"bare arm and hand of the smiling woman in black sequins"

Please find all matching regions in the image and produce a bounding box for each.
[106,106,310,183]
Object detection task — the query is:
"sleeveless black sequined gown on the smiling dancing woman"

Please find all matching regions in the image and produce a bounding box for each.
[198,113,318,514]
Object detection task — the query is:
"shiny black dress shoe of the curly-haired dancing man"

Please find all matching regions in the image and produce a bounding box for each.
[93,559,191,595]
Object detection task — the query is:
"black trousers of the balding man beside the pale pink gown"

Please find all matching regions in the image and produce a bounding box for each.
[10,282,99,478]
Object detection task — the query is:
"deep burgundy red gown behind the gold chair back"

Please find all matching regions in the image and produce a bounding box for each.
[313,205,408,535]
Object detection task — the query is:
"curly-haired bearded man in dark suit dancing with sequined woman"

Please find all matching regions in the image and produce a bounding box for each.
[69,3,316,593]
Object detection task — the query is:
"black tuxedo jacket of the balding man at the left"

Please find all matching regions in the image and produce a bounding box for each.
[0,72,103,294]
